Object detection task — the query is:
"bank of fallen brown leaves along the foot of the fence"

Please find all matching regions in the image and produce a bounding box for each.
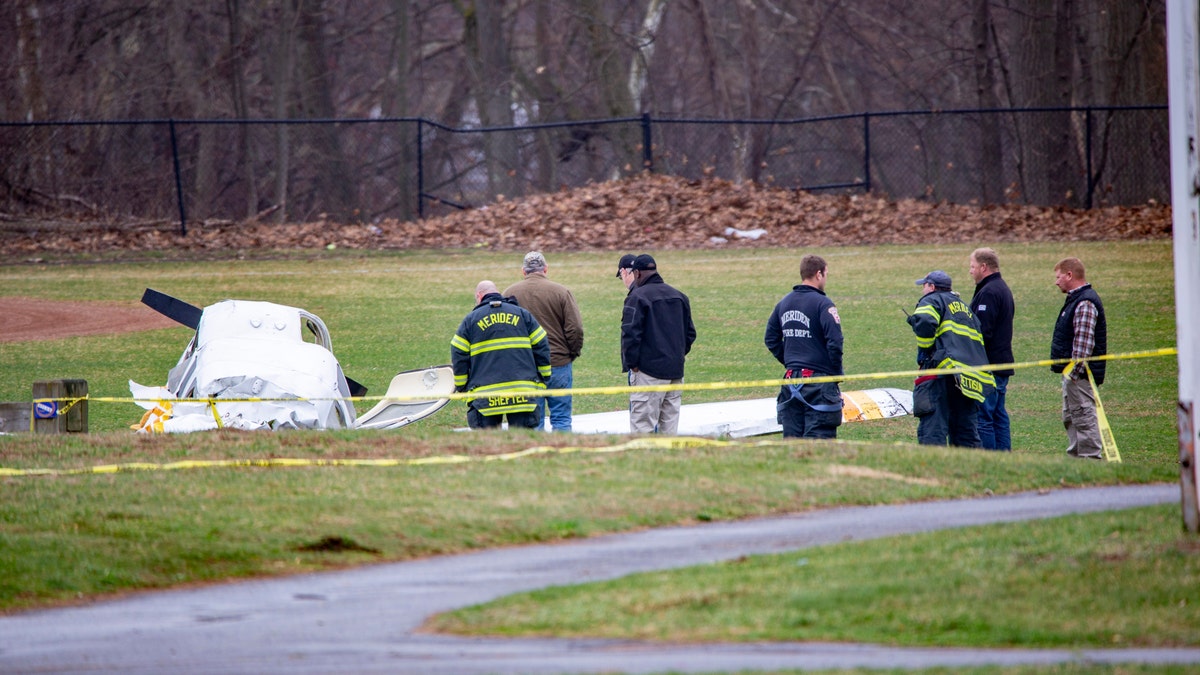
[0,174,1171,262]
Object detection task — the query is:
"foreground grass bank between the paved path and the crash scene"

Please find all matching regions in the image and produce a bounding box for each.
[0,439,1171,610]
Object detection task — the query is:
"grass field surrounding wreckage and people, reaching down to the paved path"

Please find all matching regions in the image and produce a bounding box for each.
[0,241,1200,644]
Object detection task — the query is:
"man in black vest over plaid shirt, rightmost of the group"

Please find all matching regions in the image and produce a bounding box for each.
[1050,258,1108,459]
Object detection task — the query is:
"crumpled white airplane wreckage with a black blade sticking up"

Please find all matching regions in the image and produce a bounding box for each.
[130,288,454,432]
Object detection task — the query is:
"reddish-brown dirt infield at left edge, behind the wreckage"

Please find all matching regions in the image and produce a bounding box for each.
[0,298,179,342]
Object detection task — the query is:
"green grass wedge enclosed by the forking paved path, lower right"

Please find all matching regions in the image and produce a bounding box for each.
[430,506,1200,649]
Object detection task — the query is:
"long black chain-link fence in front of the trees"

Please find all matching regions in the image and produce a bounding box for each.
[0,106,1170,232]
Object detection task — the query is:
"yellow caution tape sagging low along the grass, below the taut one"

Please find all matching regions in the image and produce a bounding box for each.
[0,436,729,477]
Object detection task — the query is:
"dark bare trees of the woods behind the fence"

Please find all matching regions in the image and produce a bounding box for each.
[0,0,1166,220]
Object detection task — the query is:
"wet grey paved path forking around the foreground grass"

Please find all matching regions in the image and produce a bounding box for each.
[0,485,1200,675]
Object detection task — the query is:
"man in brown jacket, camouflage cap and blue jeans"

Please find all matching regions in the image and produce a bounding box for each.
[504,251,583,431]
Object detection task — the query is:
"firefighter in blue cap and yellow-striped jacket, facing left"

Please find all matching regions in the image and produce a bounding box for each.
[908,270,996,448]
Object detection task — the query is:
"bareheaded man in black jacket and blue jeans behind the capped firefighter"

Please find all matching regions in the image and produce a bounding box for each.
[967,249,1016,450]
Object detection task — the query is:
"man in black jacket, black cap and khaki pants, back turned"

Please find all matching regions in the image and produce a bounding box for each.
[617,253,696,435]
